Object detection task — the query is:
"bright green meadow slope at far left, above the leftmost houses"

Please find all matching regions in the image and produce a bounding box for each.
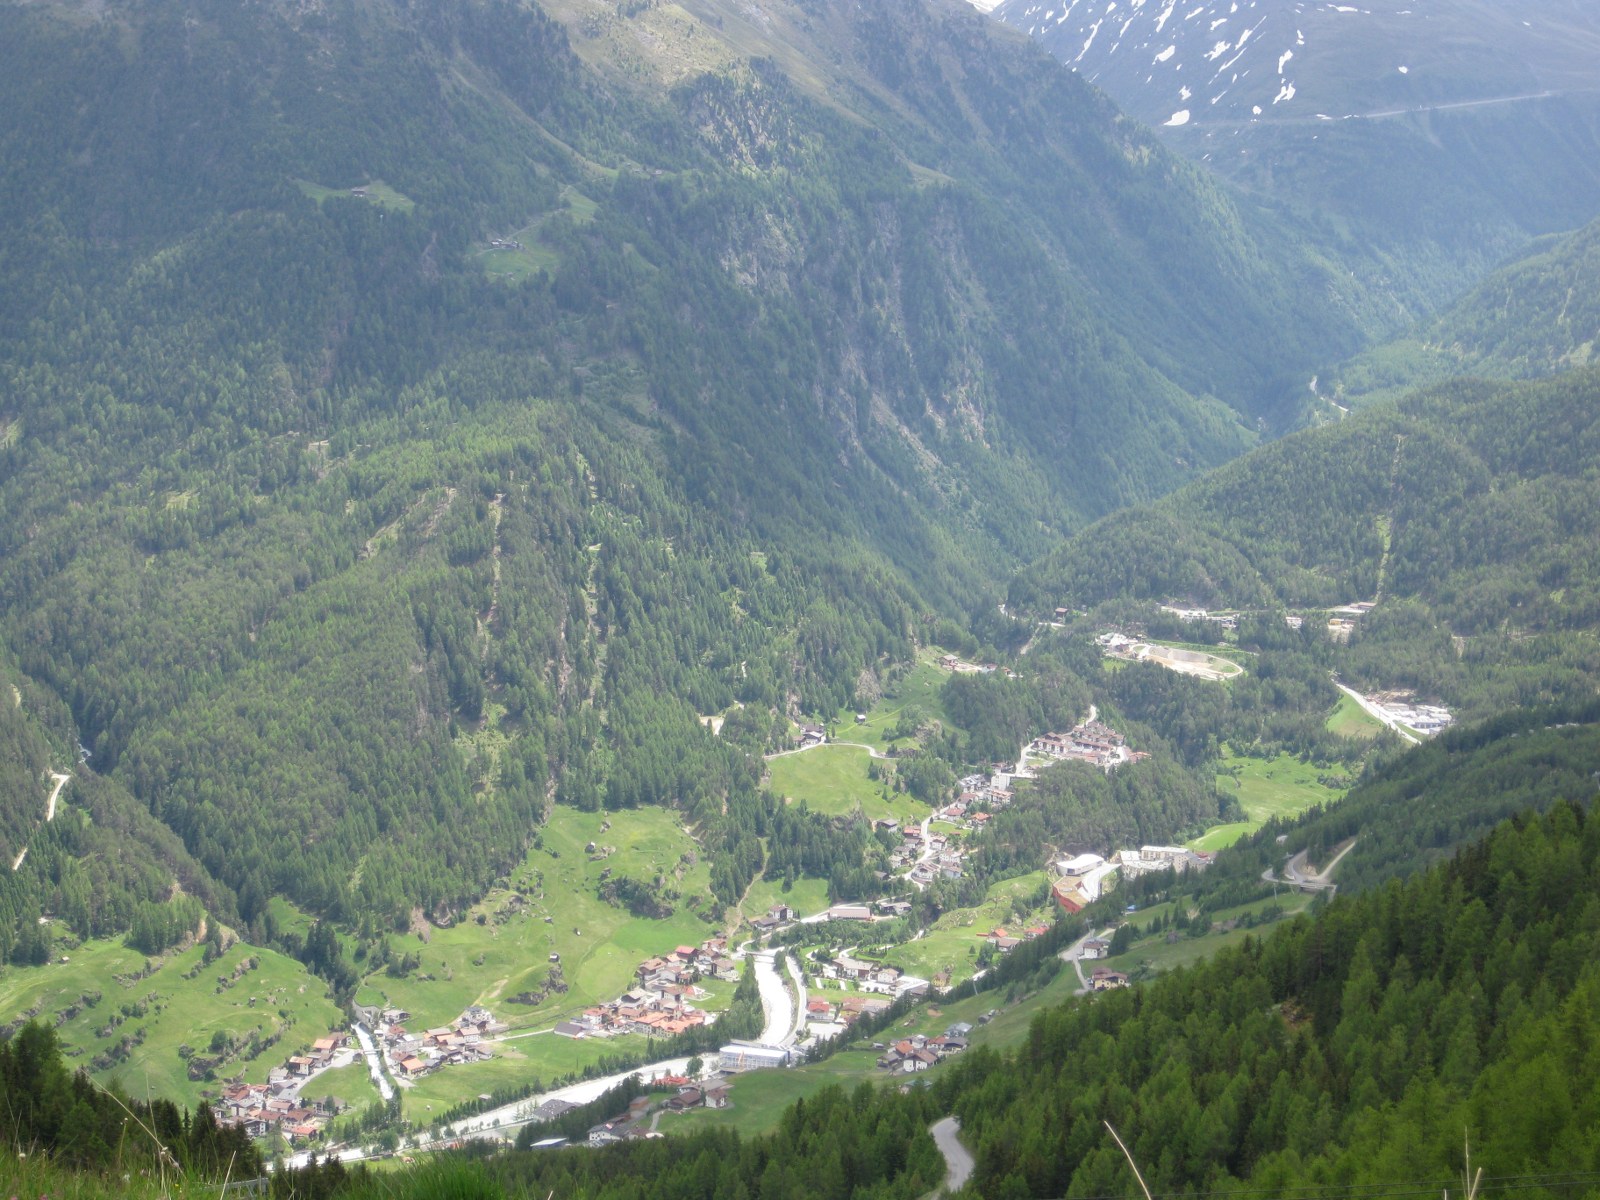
[0,939,344,1104]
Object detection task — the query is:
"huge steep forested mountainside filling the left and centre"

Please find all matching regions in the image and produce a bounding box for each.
[0,0,1381,936]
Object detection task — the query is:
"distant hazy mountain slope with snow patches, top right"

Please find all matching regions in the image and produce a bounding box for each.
[994,0,1600,339]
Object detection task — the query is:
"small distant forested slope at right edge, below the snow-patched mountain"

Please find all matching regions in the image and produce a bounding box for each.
[1306,222,1600,416]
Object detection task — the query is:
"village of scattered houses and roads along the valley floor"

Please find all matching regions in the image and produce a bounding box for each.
[203,606,1427,1147]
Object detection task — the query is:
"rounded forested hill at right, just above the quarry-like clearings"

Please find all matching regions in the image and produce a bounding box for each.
[1011,370,1600,635]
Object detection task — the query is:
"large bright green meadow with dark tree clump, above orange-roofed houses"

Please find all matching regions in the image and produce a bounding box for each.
[358,808,715,1036]
